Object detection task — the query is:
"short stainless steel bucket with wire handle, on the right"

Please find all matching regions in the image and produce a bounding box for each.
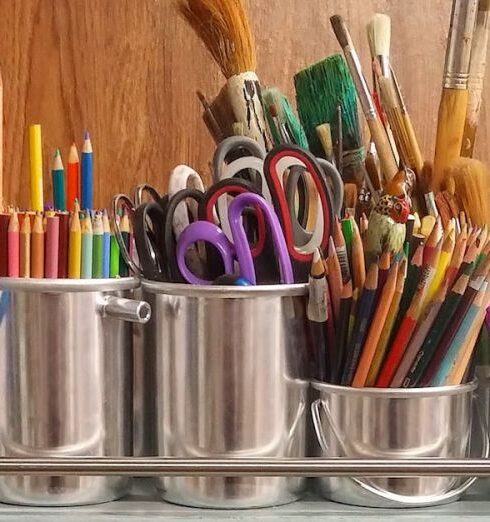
[311,382,488,507]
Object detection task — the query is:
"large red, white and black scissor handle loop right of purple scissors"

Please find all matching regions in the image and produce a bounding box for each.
[264,145,335,282]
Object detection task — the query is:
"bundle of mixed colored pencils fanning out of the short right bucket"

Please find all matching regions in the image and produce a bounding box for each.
[310,211,490,388]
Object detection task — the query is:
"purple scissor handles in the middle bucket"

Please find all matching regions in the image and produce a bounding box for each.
[176,192,294,285]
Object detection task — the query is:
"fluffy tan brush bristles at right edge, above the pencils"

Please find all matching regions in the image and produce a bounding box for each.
[445,158,490,226]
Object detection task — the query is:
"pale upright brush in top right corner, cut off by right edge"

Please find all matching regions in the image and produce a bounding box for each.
[461,0,490,158]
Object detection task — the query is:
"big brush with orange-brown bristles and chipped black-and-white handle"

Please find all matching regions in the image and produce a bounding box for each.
[179,0,269,147]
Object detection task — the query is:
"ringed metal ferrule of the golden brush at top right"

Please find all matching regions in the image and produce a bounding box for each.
[443,0,478,89]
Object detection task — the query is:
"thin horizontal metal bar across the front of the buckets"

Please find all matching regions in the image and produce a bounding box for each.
[0,457,490,477]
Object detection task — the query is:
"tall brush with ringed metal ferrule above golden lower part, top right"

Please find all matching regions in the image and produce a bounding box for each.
[432,0,478,191]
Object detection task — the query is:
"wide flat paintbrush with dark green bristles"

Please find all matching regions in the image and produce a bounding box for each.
[294,54,365,188]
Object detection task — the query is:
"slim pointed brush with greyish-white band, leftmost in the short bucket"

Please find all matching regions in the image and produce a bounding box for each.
[306,249,328,381]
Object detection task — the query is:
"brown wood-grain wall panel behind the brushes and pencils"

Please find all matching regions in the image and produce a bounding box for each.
[0,0,490,205]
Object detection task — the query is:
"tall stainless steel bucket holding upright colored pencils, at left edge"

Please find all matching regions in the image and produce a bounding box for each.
[0,278,150,506]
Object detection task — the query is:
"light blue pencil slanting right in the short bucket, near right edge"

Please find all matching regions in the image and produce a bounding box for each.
[430,281,488,386]
